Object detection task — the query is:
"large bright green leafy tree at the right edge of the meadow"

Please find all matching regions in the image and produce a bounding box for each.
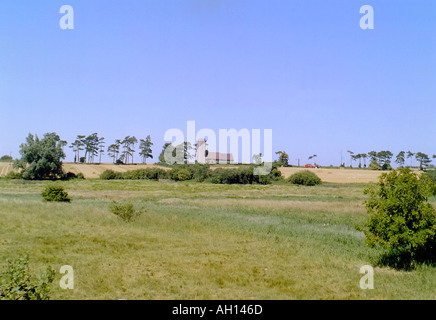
[356,168,436,266]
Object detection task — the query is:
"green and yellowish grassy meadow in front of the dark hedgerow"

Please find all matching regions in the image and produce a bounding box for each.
[0,179,436,299]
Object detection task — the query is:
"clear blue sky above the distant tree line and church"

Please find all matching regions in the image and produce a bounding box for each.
[0,0,436,165]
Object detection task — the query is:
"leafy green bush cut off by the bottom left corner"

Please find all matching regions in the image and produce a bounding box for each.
[0,253,56,300]
